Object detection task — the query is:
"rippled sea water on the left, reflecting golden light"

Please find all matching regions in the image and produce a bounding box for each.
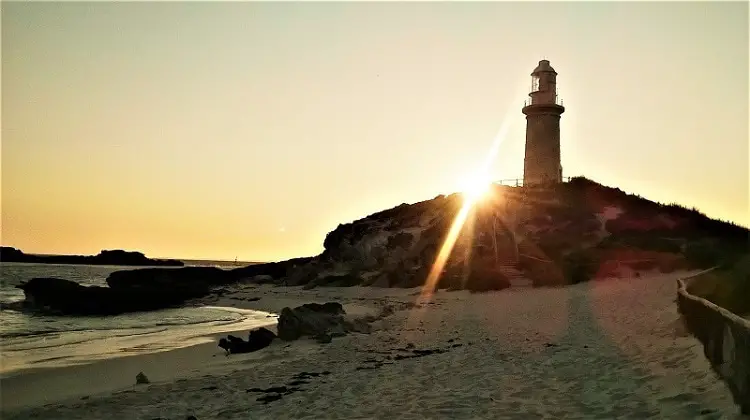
[0,261,275,377]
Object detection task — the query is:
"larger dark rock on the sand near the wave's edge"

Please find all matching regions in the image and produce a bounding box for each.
[277,302,370,342]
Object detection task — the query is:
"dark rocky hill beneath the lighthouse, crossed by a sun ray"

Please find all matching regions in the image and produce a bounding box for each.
[272,177,749,290]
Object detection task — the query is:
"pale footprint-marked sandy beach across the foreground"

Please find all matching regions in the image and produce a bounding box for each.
[2,273,740,419]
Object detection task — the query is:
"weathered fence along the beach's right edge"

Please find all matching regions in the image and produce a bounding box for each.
[677,270,750,415]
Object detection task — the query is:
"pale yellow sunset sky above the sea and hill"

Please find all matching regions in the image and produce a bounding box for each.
[0,1,750,261]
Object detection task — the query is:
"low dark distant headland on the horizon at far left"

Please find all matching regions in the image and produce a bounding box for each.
[0,246,185,267]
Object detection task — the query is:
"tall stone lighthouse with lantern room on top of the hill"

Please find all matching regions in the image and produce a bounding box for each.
[521,60,565,186]
